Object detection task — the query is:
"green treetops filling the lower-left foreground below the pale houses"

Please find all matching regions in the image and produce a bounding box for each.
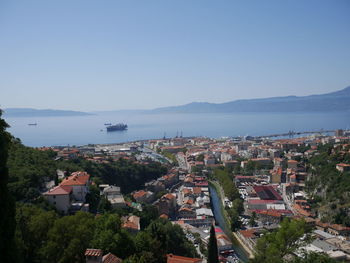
[16,204,198,263]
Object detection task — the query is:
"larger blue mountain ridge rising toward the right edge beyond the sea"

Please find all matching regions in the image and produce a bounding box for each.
[151,86,350,113]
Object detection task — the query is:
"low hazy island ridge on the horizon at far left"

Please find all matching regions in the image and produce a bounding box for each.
[4,108,91,117]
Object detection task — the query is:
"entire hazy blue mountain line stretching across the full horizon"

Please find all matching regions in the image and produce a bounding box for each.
[4,86,350,117]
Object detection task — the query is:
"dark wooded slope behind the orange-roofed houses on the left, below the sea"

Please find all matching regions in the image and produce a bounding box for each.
[7,138,167,204]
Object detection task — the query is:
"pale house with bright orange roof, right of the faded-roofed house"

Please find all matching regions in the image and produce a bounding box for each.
[60,172,90,202]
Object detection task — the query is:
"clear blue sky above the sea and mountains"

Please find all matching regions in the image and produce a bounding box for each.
[0,0,350,111]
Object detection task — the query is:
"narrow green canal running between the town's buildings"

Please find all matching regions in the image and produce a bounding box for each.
[209,184,248,262]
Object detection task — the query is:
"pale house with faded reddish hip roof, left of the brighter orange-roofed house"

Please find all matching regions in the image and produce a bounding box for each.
[44,185,73,214]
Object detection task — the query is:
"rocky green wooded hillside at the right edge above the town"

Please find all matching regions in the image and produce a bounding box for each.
[306,144,350,226]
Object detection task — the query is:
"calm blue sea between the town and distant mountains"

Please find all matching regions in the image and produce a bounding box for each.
[5,112,350,147]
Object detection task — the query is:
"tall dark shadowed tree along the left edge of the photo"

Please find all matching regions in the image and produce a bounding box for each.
[0,110,17,262]
